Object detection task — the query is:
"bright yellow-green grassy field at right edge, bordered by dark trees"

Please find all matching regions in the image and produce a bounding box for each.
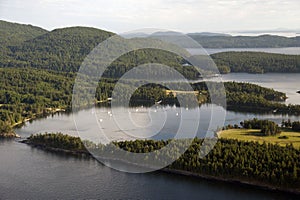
[218,129,300,149]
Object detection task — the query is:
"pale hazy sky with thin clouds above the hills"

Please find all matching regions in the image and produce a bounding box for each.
[0,0,300,33]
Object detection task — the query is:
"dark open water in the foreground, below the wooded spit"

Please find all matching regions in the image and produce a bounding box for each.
[0,141,296,200]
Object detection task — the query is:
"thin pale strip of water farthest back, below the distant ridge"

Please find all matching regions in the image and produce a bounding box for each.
[187,47,300,55]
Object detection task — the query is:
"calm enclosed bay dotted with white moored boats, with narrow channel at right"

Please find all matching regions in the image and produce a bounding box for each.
[16,104,300,142]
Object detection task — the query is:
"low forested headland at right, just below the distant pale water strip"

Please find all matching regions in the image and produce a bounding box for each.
[211,52,300,73]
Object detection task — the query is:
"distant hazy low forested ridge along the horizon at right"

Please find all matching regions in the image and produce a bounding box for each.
[188,34,300,48]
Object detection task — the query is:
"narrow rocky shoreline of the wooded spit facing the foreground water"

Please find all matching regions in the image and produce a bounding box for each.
[19,140,300,196]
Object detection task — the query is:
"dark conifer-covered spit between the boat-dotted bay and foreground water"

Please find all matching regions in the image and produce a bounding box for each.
[24,133,300,194]
